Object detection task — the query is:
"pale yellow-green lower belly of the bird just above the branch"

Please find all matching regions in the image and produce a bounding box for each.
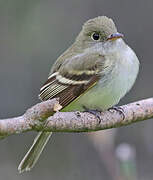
[63,78,126,111]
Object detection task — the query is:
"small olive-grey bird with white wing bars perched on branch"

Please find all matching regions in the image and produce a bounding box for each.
[18,16,139,172]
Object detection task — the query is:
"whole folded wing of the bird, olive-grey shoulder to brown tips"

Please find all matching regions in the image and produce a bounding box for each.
[39,51,104,108]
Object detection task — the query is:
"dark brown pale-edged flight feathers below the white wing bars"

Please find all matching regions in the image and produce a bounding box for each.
[39,75,99,108]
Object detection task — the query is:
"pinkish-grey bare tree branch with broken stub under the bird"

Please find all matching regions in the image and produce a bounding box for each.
[0,98,153,137]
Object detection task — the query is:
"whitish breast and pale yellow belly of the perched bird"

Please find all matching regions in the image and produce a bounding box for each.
[62,46,139,110]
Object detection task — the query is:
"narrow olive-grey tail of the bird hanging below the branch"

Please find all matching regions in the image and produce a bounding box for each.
[18,132,52,173]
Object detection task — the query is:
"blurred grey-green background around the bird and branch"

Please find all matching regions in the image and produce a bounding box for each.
[0,0,153,180]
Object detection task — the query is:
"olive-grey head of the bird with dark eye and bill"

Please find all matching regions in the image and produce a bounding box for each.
[76,16,123,46]
